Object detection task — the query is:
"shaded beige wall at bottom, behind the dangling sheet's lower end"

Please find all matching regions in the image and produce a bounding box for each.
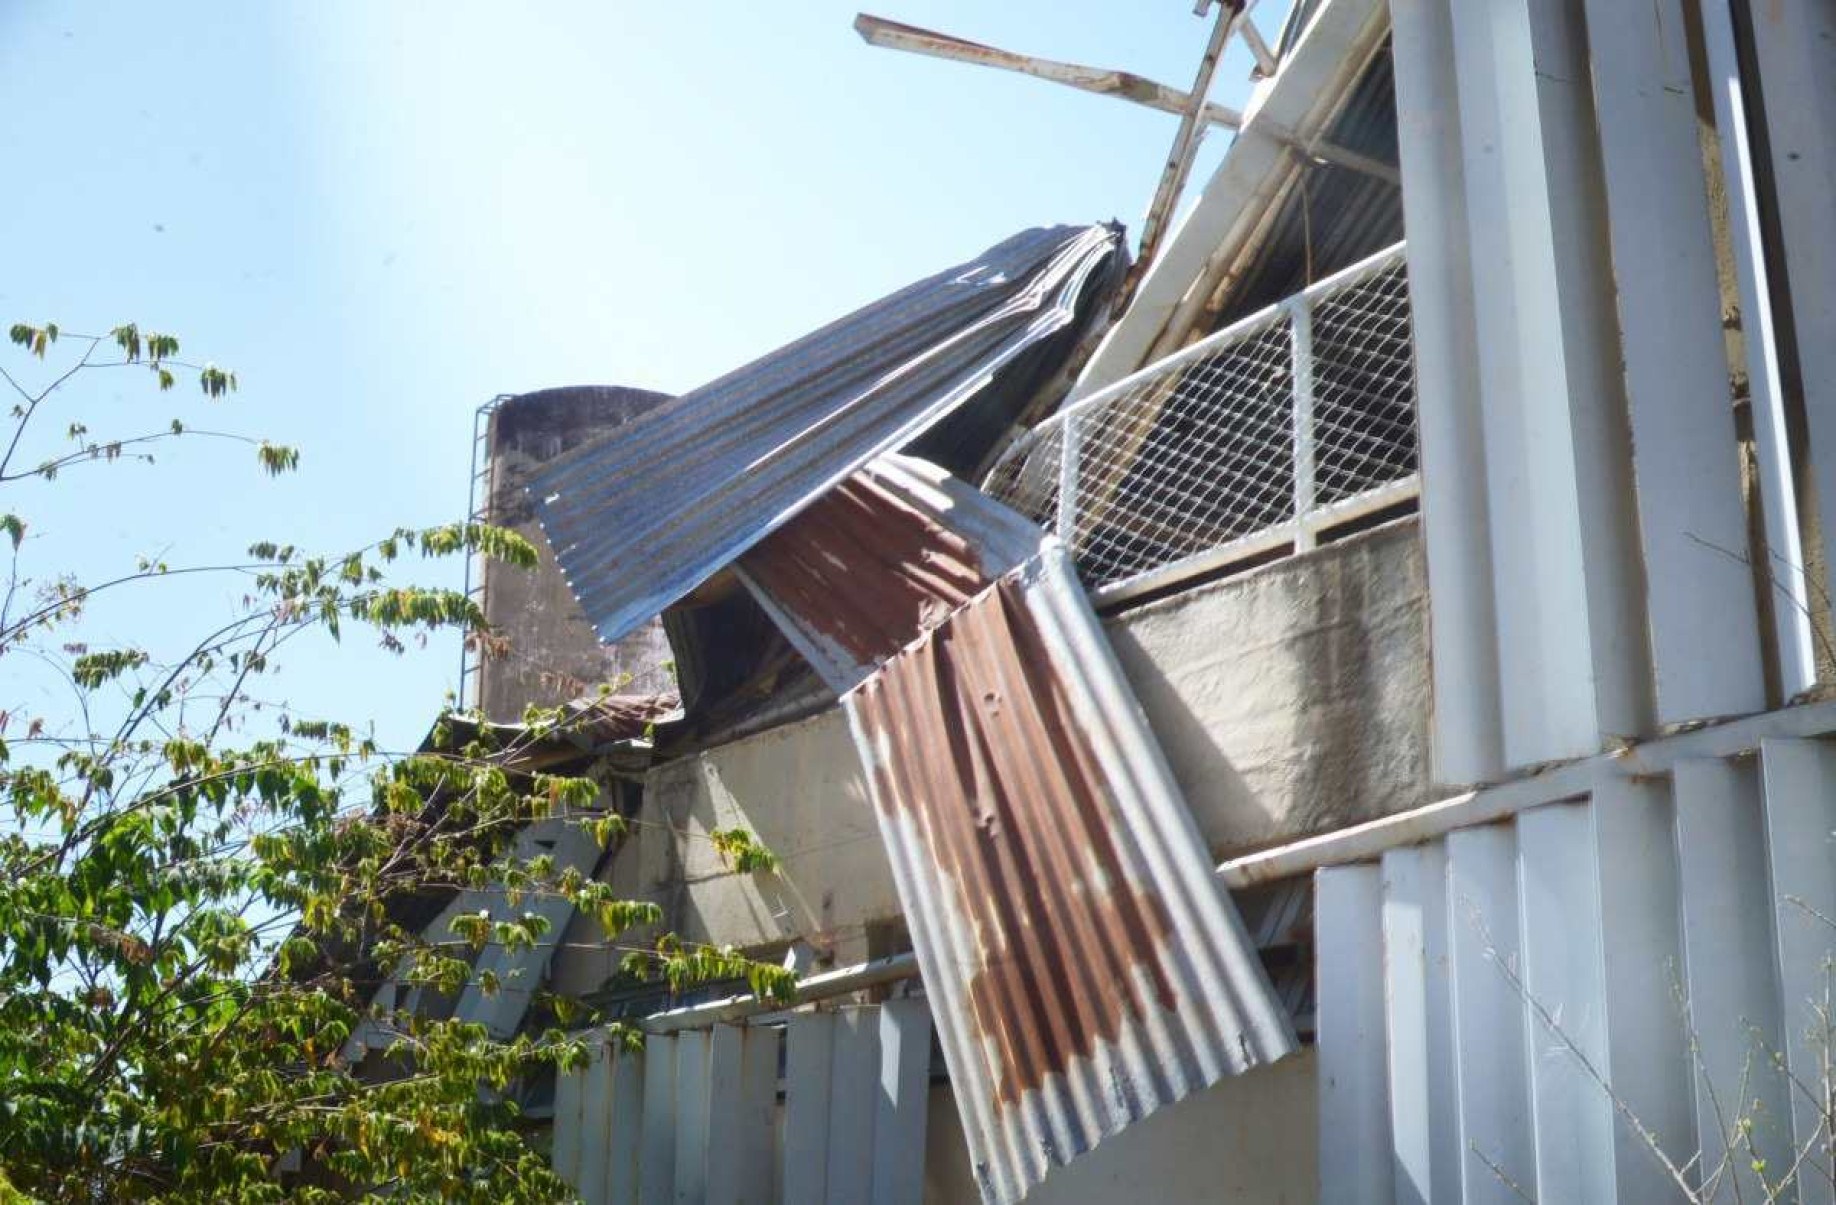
[924,1047,1318,1205]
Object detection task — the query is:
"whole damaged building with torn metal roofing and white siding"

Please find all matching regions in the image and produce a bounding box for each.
[372,0,1836,1201]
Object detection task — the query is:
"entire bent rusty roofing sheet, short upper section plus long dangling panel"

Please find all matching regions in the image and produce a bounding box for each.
[742,456,1294,1201]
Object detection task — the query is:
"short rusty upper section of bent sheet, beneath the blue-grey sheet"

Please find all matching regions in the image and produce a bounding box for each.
[738,456,1039,693]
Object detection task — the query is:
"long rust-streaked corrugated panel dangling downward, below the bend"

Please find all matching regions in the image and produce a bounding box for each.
[843,540,1294,1201]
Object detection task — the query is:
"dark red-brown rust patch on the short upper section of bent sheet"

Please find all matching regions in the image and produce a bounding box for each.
[740,472,988,665]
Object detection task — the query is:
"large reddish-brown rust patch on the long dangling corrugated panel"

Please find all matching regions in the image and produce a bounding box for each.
[854,579,1175,1104]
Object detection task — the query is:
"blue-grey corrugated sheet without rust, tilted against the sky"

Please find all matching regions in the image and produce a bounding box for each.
[531,226,1122,641]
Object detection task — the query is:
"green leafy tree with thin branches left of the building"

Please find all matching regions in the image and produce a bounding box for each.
[0,323,791,1201]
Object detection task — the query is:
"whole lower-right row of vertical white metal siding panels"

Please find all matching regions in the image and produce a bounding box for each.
[1315,738,1836,1203]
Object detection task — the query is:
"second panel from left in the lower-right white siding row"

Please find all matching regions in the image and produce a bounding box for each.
[1383,843,1460,1205]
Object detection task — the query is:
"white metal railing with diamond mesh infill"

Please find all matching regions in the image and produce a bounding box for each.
[982,242,1417,599]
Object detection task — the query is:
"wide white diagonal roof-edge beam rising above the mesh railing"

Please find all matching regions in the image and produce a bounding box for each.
[1067,0,1390,402]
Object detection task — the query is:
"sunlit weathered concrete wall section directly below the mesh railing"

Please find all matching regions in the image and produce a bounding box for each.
[1107,518,1432,858]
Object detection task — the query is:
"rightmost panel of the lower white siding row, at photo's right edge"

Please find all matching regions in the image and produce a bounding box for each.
[1761,740,1836,1205]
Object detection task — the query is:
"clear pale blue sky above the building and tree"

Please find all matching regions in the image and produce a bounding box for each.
[0,0,1285,744]
